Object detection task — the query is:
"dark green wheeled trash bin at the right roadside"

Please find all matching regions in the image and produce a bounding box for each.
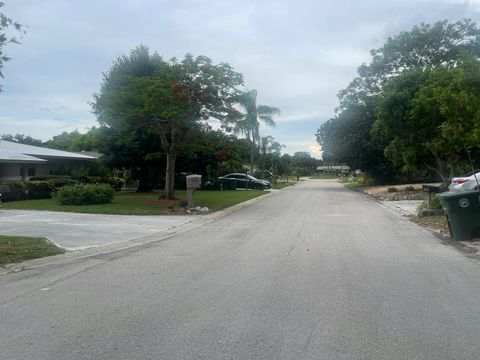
[437,190,480,240]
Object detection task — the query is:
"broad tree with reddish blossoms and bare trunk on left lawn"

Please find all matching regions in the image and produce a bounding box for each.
[93,46,243,199]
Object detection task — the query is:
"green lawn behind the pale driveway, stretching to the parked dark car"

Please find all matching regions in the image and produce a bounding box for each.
[2,190,268,215]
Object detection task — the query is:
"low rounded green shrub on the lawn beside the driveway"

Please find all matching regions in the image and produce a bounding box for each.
[54,184,115,205]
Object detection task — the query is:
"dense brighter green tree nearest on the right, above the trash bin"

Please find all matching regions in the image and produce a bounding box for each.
[372,55,480,186]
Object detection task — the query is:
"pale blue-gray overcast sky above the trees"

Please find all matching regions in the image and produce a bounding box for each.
[0,0,480,155]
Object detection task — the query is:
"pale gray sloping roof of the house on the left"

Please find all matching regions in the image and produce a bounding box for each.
[0,140,95,163]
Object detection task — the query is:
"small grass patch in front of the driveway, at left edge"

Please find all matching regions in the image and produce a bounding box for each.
[0,235,65,266]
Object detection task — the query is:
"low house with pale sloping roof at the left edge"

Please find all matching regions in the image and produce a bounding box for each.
[0,140,95,181]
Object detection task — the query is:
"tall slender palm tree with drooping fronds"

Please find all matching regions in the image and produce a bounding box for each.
[235,90,280,174]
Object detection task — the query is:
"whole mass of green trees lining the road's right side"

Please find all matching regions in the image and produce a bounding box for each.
[316,19,480,188]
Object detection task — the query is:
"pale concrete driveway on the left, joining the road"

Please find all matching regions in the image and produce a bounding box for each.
[0,210,198,250]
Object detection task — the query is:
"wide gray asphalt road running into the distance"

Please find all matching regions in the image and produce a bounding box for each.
[0,181,480,360]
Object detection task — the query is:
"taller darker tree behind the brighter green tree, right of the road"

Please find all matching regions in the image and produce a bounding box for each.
[317,19,480,178]
